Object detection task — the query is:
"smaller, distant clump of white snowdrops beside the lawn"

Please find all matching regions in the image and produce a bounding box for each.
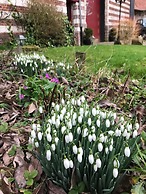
[13,53,72,76]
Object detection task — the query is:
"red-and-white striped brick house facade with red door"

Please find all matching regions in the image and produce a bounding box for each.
[0,0,134,45]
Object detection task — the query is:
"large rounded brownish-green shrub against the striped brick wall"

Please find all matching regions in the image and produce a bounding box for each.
[14,1,72,46]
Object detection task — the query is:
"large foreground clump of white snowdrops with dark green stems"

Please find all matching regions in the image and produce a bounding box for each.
[30,96,139,194]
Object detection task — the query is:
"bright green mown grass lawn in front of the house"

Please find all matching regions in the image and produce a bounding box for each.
[43,45,146,79]
